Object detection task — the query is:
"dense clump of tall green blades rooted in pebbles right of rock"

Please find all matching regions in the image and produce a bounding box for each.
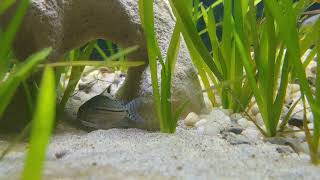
[170,0,320,162]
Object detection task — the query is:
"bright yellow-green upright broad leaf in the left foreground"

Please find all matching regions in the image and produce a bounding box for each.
[22,68,56,180]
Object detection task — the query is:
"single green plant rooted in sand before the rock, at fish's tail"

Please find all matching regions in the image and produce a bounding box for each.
[139,0,187,133]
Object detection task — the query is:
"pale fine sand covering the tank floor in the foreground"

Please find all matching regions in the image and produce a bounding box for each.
[0,117,320,179]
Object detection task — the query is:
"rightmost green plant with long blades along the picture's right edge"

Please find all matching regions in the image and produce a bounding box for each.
[264,0,320,164]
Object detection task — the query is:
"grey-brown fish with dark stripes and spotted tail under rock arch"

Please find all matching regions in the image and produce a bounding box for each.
[77,94,145,129]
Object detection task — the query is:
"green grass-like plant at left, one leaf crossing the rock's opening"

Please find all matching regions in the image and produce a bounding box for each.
[0,0,144,179]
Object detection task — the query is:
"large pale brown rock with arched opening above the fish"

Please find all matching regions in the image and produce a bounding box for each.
[0,0,205,129]
